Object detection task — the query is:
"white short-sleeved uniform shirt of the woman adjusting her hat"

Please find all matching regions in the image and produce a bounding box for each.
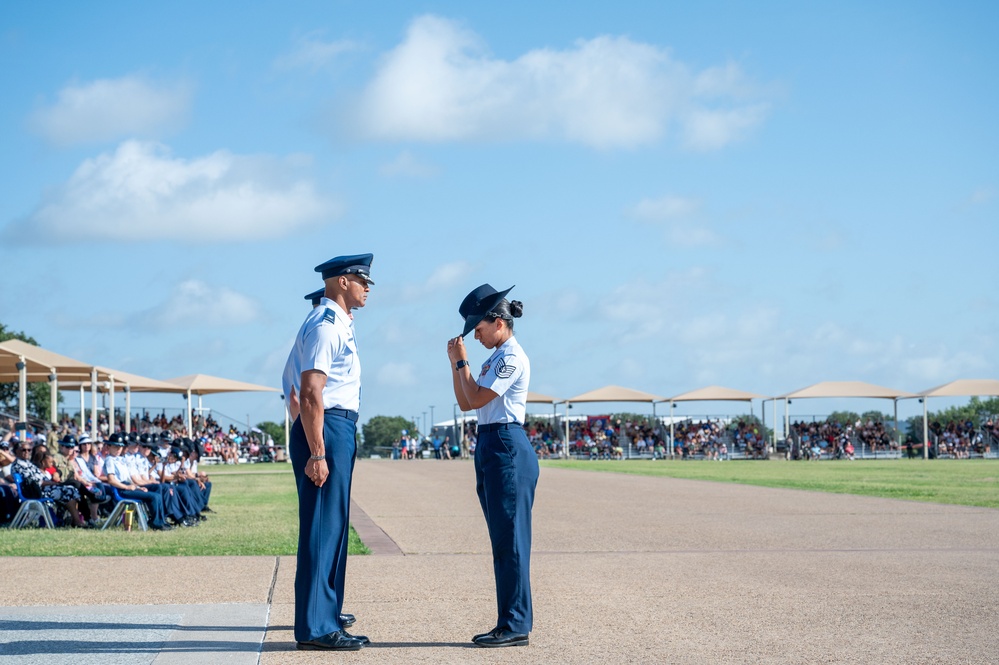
[476,337,531,425]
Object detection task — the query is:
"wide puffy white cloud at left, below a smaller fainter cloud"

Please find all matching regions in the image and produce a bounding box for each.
[3,141,339,243]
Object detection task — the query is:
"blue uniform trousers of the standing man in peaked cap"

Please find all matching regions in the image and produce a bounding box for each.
[290,413,357,642]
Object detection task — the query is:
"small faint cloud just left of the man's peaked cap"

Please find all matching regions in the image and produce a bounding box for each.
[137,279,261,329]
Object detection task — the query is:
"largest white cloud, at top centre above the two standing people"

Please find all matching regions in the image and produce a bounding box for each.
[353,16,767,150]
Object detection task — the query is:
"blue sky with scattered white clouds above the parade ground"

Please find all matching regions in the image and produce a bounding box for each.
[0,1,999,434]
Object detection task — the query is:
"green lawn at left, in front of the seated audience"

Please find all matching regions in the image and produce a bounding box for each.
[0,464,370,556]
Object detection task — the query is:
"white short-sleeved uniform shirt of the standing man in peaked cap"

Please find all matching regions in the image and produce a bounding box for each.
[292,298,361,411]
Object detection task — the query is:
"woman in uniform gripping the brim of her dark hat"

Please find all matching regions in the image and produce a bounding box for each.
[447,284,538,647]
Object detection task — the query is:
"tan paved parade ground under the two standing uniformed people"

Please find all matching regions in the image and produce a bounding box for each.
[0,460,999,665]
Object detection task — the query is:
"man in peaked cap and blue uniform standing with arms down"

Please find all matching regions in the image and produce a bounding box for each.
[290,254,373,651]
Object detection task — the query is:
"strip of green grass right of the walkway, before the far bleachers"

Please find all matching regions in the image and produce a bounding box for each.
[542,459,999,508]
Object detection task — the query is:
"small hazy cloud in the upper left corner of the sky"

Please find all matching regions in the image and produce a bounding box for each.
[28,76,193,145]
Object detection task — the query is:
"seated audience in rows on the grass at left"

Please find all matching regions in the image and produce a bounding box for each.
[0,420,211,530]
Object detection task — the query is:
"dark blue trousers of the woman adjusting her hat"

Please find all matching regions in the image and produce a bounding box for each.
[475,426,538,633]
